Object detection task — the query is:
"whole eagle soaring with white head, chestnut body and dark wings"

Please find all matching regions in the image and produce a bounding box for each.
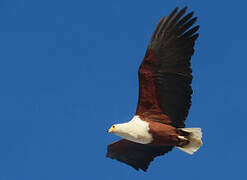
[106,7,202,171]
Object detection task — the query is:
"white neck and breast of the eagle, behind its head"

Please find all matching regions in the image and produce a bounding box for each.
[115,116,153,144]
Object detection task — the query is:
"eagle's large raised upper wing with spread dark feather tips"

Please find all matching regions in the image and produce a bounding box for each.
[136,7,199,127]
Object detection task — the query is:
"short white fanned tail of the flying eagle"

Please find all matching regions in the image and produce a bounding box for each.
[177,128,202,155]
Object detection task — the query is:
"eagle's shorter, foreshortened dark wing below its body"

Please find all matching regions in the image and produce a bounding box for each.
[106,139,173,171]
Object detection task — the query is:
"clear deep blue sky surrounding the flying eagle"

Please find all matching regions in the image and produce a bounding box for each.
[0,0,247,180]
